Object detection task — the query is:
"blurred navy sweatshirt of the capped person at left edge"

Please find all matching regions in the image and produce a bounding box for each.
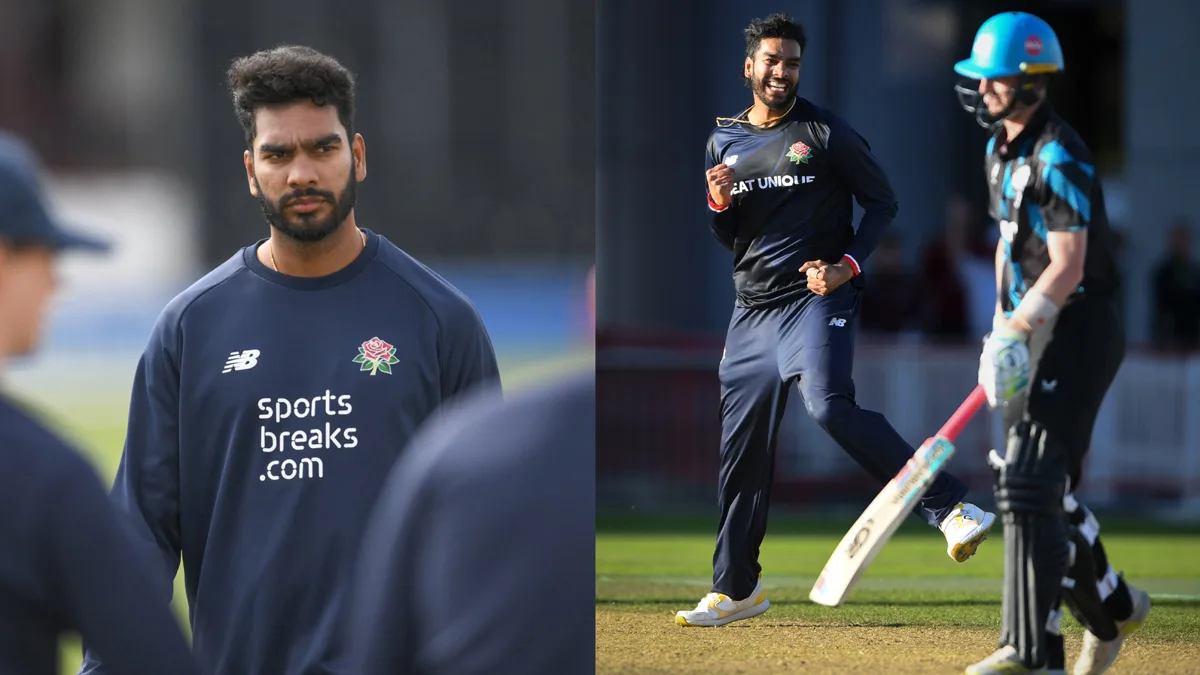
[0,399,197,675]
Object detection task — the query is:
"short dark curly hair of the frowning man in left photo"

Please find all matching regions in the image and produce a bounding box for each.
[227,44,354,147]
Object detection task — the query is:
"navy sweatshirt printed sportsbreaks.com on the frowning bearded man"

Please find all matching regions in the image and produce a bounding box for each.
[84,227,499,675]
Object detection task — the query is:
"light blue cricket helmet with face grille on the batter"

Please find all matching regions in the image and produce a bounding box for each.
[954,12,1063,129]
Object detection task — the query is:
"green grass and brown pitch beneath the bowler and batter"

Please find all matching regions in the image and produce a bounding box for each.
[596,514,1200,675]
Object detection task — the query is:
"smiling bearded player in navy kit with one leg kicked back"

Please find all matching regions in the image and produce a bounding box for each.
[676,14,995,626]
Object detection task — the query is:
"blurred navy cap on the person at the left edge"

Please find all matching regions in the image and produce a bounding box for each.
[0,131,110,251]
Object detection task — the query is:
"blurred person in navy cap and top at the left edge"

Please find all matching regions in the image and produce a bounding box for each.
[0,132,197,675]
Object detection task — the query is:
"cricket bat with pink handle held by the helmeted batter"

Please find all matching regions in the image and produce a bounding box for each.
[809,387,988,607]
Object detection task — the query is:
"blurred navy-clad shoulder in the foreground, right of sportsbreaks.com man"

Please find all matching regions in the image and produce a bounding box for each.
[349,268,595,675]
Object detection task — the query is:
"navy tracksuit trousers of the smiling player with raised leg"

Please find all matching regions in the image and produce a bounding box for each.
[713,282,967,599]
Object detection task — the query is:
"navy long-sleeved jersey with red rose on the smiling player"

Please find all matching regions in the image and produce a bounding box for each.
[706,98,899,307]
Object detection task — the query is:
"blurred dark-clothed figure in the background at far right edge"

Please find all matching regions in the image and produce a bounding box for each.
[1153,217,1200,350]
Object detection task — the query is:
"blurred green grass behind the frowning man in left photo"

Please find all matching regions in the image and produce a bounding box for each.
[3,347,595,675]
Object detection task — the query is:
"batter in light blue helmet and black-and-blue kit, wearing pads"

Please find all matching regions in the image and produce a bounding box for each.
[954,12,1150,675]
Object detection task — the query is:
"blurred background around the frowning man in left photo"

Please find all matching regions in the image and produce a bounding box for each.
[0,0,595,673]
